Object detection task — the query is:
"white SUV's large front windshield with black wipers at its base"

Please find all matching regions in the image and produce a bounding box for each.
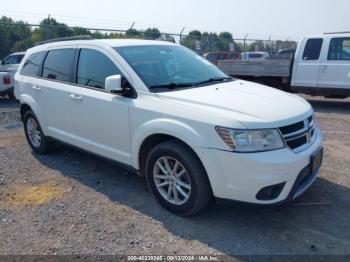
[115,45,232,91]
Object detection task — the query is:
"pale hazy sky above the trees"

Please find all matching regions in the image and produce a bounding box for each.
[0,0,350,40]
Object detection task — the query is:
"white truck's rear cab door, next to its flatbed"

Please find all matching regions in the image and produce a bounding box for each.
[292,38,323,87]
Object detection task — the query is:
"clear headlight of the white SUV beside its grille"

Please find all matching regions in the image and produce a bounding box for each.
[216,127,285,152]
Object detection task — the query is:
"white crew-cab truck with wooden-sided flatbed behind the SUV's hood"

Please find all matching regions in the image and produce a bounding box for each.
[218,32,350,98]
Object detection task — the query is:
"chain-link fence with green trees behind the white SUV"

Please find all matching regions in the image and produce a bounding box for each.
[0,19,296,59]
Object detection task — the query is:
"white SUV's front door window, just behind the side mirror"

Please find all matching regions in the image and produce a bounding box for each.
[77,49,121,89]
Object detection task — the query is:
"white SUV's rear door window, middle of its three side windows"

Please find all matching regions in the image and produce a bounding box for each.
[43,49,75,82]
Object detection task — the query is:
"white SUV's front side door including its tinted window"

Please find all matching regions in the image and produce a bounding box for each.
[68,48,133,164]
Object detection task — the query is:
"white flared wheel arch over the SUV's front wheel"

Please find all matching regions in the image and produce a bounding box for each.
[131,119,204,169]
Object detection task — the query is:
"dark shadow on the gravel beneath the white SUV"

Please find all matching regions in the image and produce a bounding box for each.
[34,146,350,255]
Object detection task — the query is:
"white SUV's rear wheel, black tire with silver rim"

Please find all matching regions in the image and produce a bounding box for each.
[23,110,52,154]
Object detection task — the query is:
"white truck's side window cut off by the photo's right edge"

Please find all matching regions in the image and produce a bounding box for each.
[328,37,350,60]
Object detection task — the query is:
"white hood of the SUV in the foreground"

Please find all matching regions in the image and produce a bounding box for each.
[157,80,312,128]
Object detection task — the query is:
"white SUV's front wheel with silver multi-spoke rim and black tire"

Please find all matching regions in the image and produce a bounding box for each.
[145,140,212,216]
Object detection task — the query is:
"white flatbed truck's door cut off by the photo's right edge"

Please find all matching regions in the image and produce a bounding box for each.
[318,37,350,88]
